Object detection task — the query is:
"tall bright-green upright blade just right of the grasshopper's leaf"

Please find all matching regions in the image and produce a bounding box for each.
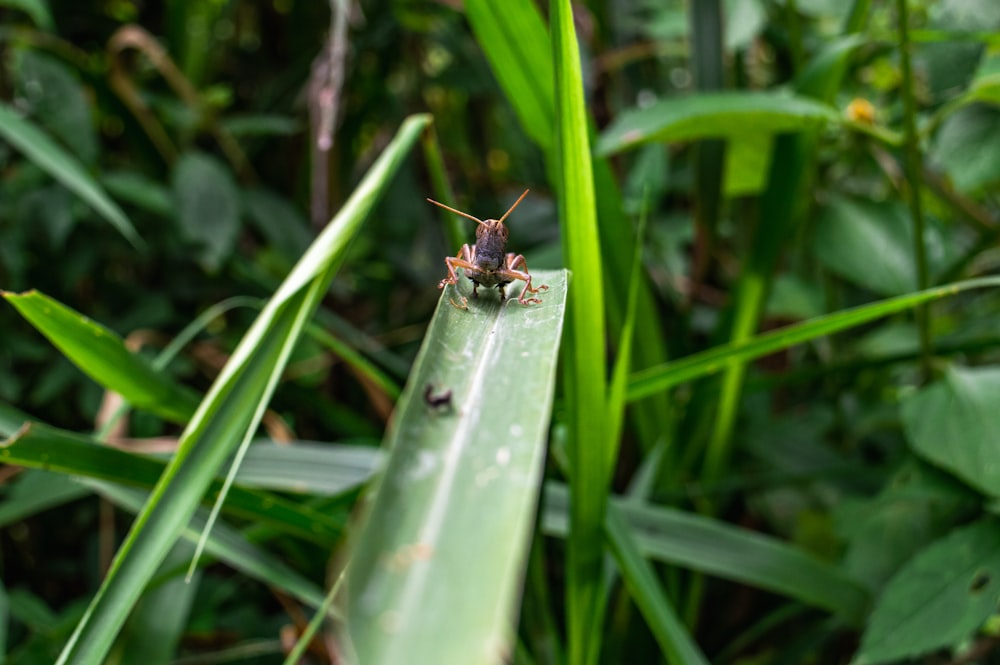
[549,0,610,665]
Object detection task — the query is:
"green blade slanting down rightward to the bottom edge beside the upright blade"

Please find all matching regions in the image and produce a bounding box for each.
[606,505,708,665]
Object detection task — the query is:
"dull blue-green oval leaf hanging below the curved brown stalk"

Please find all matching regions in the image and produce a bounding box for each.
[173,152,240,272]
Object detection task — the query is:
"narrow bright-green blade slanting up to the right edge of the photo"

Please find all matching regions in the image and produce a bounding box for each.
[628,277,1000,400]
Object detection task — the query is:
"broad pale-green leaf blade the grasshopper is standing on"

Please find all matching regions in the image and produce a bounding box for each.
[346,271,567,665]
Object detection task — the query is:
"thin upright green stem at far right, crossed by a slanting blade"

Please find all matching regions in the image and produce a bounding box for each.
[896,0,931,381]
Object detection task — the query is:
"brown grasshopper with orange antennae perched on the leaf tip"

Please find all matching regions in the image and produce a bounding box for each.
[427,189,549,308]
